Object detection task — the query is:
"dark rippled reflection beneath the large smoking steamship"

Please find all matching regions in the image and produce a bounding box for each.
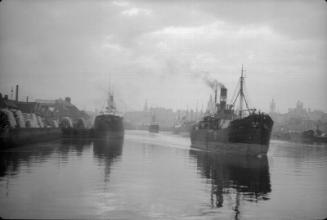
[190,150,271,219]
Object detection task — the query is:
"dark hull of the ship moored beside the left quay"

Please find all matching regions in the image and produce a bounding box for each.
[92,114,124,140]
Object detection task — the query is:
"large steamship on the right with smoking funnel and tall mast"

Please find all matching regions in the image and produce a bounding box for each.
[191,66,273,155]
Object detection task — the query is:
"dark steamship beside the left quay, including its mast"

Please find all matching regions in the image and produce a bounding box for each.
[93,88,124,140]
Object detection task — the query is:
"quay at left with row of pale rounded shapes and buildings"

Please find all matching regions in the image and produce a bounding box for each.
[0,85,92,149]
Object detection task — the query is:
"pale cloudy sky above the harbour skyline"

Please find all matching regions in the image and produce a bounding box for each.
[0,0,327,112]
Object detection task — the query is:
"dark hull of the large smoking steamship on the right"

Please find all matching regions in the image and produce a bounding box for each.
[191,114,273,155]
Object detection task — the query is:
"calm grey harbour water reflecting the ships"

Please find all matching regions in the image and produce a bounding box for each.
[0,131,327,219]
